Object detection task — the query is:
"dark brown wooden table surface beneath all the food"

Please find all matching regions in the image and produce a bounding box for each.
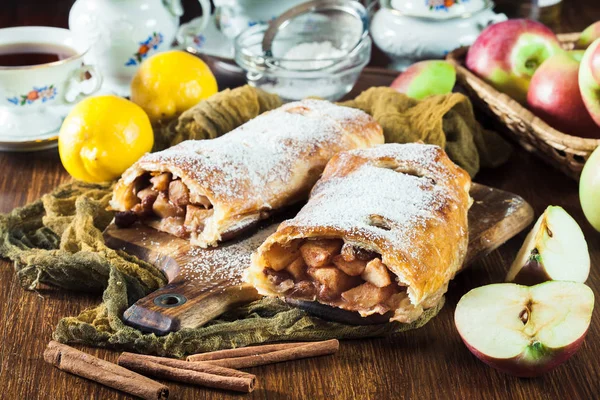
[0,0,600,400]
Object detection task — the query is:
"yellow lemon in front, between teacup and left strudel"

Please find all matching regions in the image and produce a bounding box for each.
[58,96,154,182]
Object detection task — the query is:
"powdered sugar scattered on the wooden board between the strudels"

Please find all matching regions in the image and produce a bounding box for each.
[181,225,277,289]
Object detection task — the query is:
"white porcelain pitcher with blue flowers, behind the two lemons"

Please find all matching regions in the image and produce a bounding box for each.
[69,0,210,96]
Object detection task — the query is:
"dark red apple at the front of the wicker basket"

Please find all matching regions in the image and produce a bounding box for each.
[527,50,600,138]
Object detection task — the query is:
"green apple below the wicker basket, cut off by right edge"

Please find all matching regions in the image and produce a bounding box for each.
[579,147,600,232]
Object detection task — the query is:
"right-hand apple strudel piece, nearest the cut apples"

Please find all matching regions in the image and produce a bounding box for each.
[245,144,472,323]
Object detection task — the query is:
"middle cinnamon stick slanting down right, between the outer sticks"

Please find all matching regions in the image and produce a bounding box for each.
[117,353,255,393]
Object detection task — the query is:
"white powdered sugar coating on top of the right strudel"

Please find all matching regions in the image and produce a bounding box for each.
[285,144,455,259]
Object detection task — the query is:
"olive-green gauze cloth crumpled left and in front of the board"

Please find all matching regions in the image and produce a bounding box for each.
[0,182,443,357]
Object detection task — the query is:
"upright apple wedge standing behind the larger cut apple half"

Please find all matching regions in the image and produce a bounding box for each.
[506,206,590,285]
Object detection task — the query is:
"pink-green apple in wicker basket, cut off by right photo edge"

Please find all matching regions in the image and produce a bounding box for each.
[579,39,600,125]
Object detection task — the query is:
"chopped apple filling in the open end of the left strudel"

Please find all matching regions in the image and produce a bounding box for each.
[115,172,213,238]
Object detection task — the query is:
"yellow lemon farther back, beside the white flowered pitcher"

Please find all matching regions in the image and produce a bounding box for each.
[131,50,218,122]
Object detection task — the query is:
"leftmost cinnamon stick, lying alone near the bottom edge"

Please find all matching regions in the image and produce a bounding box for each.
[44,341,169,400]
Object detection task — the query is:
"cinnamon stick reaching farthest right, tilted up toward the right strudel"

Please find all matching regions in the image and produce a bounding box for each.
[195,339,340,368]
